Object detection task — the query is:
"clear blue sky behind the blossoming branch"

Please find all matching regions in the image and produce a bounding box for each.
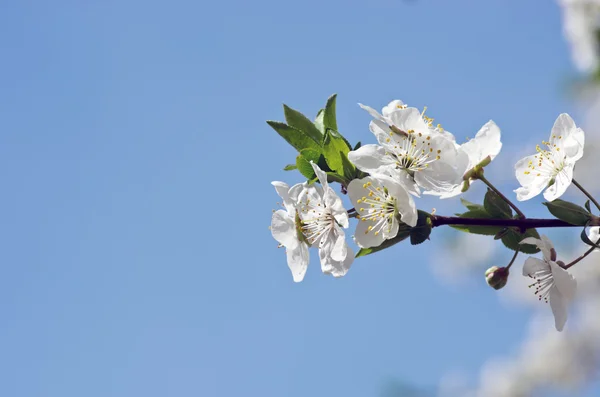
[0,0,592,397]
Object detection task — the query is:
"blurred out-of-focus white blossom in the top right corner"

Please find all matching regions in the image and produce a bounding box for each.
[560,0,600,72]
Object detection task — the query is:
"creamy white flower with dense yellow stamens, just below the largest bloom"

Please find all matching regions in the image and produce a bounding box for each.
[348,175,418,248]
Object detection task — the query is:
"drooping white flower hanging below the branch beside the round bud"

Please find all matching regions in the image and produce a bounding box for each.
[520,236,577,331]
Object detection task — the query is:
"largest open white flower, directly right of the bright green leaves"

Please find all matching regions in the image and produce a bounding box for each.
[348,101,464,195]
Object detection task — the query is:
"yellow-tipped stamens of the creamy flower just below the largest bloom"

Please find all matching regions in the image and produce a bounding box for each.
[356,182,398,236]
